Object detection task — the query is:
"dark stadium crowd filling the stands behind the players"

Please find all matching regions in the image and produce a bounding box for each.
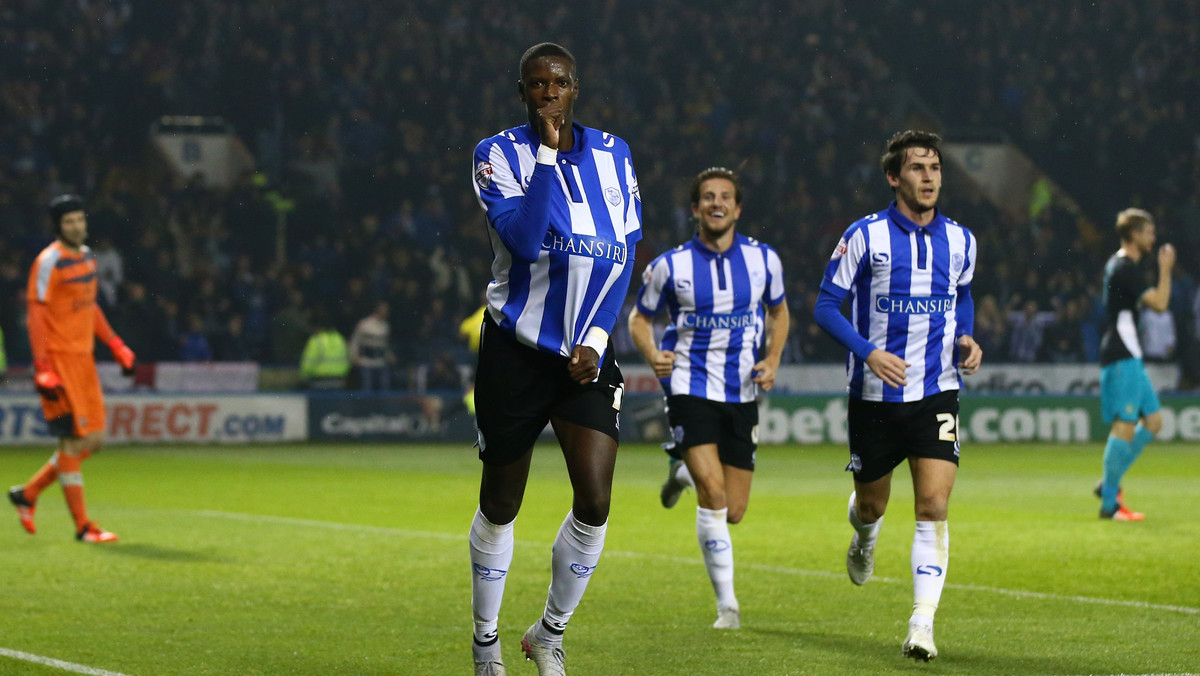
[0,0,1200,388]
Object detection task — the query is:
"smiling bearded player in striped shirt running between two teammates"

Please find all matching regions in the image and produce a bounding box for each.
[629,167,788,629]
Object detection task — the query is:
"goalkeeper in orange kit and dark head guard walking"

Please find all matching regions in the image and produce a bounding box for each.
[8,195,134,543]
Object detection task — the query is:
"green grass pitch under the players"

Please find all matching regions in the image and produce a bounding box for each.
[0,443,1200,676]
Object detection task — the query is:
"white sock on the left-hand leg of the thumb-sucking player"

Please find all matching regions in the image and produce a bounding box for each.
[467,509,512,646]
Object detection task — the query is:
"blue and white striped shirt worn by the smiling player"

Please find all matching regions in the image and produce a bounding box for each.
[637,234,784,403]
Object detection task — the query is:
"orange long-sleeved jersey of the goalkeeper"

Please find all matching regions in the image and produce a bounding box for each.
[26,240,99,358]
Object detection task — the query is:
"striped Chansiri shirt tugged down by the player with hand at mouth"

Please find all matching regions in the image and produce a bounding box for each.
[474,124,642,359]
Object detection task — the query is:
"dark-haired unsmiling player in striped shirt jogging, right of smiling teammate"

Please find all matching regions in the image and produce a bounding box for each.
[815,131,983,662]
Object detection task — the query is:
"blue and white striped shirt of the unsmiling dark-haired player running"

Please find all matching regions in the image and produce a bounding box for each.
[818,203,976,401]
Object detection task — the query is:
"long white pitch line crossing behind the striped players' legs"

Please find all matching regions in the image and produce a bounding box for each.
[190,509,1200,614]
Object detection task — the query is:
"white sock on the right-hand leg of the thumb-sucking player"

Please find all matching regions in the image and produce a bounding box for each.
[538,512,608,646]
